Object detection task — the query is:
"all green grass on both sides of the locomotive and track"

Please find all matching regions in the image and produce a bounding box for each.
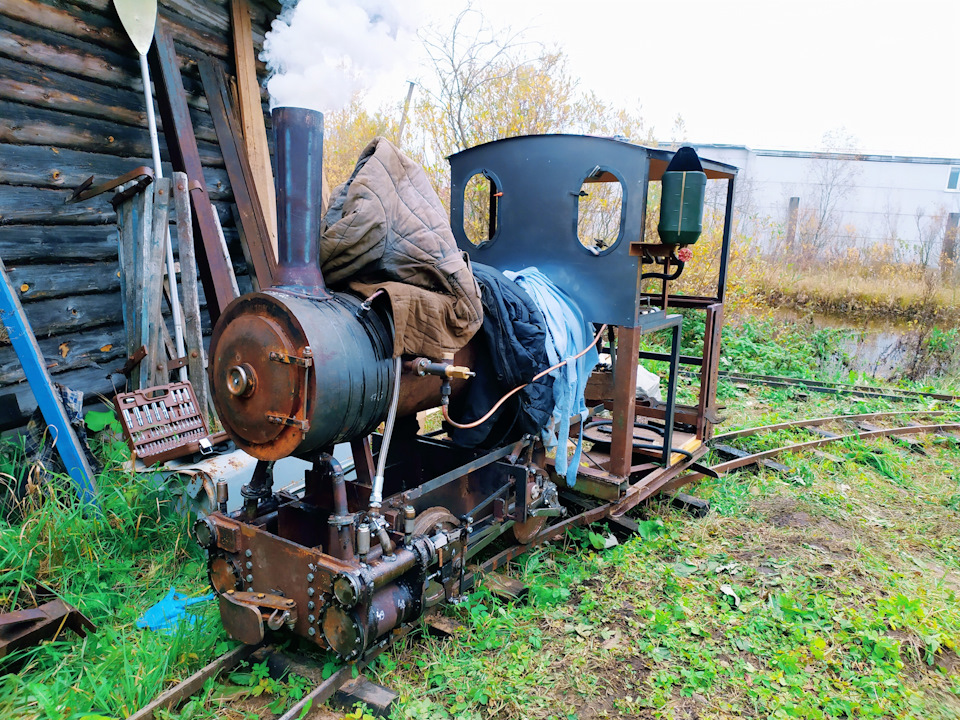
[0,323,960,720]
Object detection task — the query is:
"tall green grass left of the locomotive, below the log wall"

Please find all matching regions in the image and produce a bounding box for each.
[0,430,234,718]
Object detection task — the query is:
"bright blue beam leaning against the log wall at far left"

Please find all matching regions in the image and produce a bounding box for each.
[0,259,96,504]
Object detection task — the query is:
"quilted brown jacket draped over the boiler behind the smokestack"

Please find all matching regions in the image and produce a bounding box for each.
[320,137,483,359]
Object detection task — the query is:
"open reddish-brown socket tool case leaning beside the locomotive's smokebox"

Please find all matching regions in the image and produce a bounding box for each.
[116,381,210,465]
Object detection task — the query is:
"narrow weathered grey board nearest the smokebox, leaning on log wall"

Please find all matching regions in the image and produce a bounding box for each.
[173,172,210,424]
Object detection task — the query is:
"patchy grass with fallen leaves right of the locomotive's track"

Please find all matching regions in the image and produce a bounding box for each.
[378,389,960,719]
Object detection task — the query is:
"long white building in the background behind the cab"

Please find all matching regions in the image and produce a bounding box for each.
[694,144,960,265]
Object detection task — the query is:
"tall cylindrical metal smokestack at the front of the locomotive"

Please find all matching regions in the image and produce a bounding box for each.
[273,107,330,298]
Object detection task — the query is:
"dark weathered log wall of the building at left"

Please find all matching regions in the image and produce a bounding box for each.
[0,0,280,430]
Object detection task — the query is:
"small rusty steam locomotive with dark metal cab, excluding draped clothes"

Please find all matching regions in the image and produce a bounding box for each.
[195,108,736,660]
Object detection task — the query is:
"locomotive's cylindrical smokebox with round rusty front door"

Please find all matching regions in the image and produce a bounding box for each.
[210,290,393,460]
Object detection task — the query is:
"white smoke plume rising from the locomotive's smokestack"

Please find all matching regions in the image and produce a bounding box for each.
[260,0,418,112]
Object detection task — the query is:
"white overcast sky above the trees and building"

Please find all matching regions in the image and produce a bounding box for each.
[366,0,960,158]
